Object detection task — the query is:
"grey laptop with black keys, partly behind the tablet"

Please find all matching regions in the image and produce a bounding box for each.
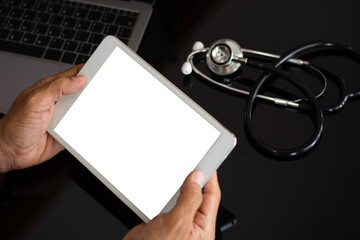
[0,0,155,113]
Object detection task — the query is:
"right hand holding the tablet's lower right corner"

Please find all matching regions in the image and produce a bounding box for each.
[123,171,221,240]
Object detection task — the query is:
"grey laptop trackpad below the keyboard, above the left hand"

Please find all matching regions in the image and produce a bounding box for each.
[0,53,62,113]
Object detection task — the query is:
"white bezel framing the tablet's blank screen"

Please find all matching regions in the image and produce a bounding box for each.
[48,36,236,222]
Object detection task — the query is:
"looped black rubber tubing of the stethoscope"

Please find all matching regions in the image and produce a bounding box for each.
[244,42,360,159]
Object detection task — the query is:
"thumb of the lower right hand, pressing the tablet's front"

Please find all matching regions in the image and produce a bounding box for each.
[171,170,204,222]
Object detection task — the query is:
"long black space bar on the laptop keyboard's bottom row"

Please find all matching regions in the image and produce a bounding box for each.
[0,39,45,58]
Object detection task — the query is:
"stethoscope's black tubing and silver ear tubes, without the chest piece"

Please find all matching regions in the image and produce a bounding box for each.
[187,40,360,159]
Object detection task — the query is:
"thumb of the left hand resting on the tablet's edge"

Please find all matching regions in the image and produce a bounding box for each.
[29,75,86,111]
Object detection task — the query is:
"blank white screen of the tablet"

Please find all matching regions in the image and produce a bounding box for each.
[54,47,220,219]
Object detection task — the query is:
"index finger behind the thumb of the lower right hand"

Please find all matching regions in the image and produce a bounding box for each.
[197,172,221,224]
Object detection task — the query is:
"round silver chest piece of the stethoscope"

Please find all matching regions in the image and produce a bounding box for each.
[206,39,244,76]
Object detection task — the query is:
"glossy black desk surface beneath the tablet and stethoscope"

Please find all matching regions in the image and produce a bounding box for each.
[0,0,360,239]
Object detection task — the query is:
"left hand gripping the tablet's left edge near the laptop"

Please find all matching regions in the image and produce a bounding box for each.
[0,65,85,172]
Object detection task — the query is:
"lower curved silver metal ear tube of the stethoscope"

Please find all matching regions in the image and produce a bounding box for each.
[187,48,299,108]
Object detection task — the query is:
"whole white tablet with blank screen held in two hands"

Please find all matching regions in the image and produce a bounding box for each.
[48,36,236,222]
